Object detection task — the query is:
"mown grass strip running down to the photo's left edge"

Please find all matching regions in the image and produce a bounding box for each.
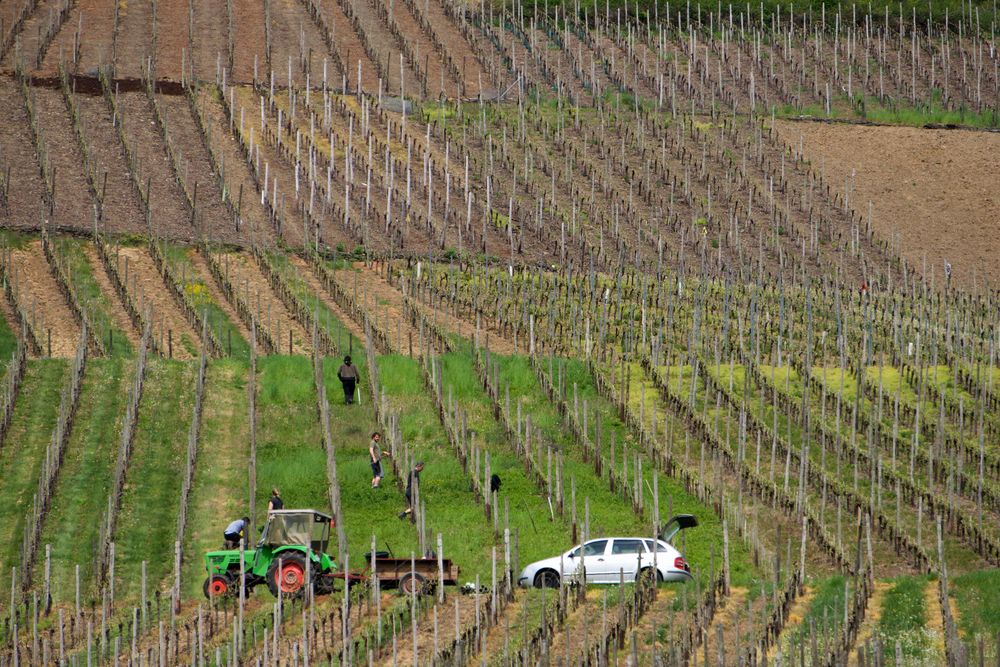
[0,359,68,573]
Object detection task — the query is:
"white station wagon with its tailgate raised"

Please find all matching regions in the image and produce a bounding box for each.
[517,514,698,588]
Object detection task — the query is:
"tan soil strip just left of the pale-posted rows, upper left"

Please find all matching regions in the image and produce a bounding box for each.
[198,89,275,245]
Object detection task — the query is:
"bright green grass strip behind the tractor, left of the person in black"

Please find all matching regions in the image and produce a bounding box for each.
[256,356,330,527]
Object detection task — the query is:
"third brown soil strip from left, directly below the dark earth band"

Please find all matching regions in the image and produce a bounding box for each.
[75,95,147,233]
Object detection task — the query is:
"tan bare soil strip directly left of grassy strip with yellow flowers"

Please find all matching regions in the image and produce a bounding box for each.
[118,247,201,359]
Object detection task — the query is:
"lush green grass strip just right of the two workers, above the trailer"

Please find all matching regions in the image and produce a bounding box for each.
[378,355,494,581]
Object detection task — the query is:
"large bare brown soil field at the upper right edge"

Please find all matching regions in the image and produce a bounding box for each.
[777,121,1000,286]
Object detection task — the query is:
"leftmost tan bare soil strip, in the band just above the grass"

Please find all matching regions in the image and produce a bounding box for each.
[11,241,80,357]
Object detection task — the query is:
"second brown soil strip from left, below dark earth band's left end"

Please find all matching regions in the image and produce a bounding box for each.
[32,87,94,230]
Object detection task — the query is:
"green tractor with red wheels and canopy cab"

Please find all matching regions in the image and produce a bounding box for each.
[202,510,337,599]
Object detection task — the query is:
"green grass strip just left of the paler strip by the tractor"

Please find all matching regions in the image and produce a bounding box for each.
[114,358,197,598]
